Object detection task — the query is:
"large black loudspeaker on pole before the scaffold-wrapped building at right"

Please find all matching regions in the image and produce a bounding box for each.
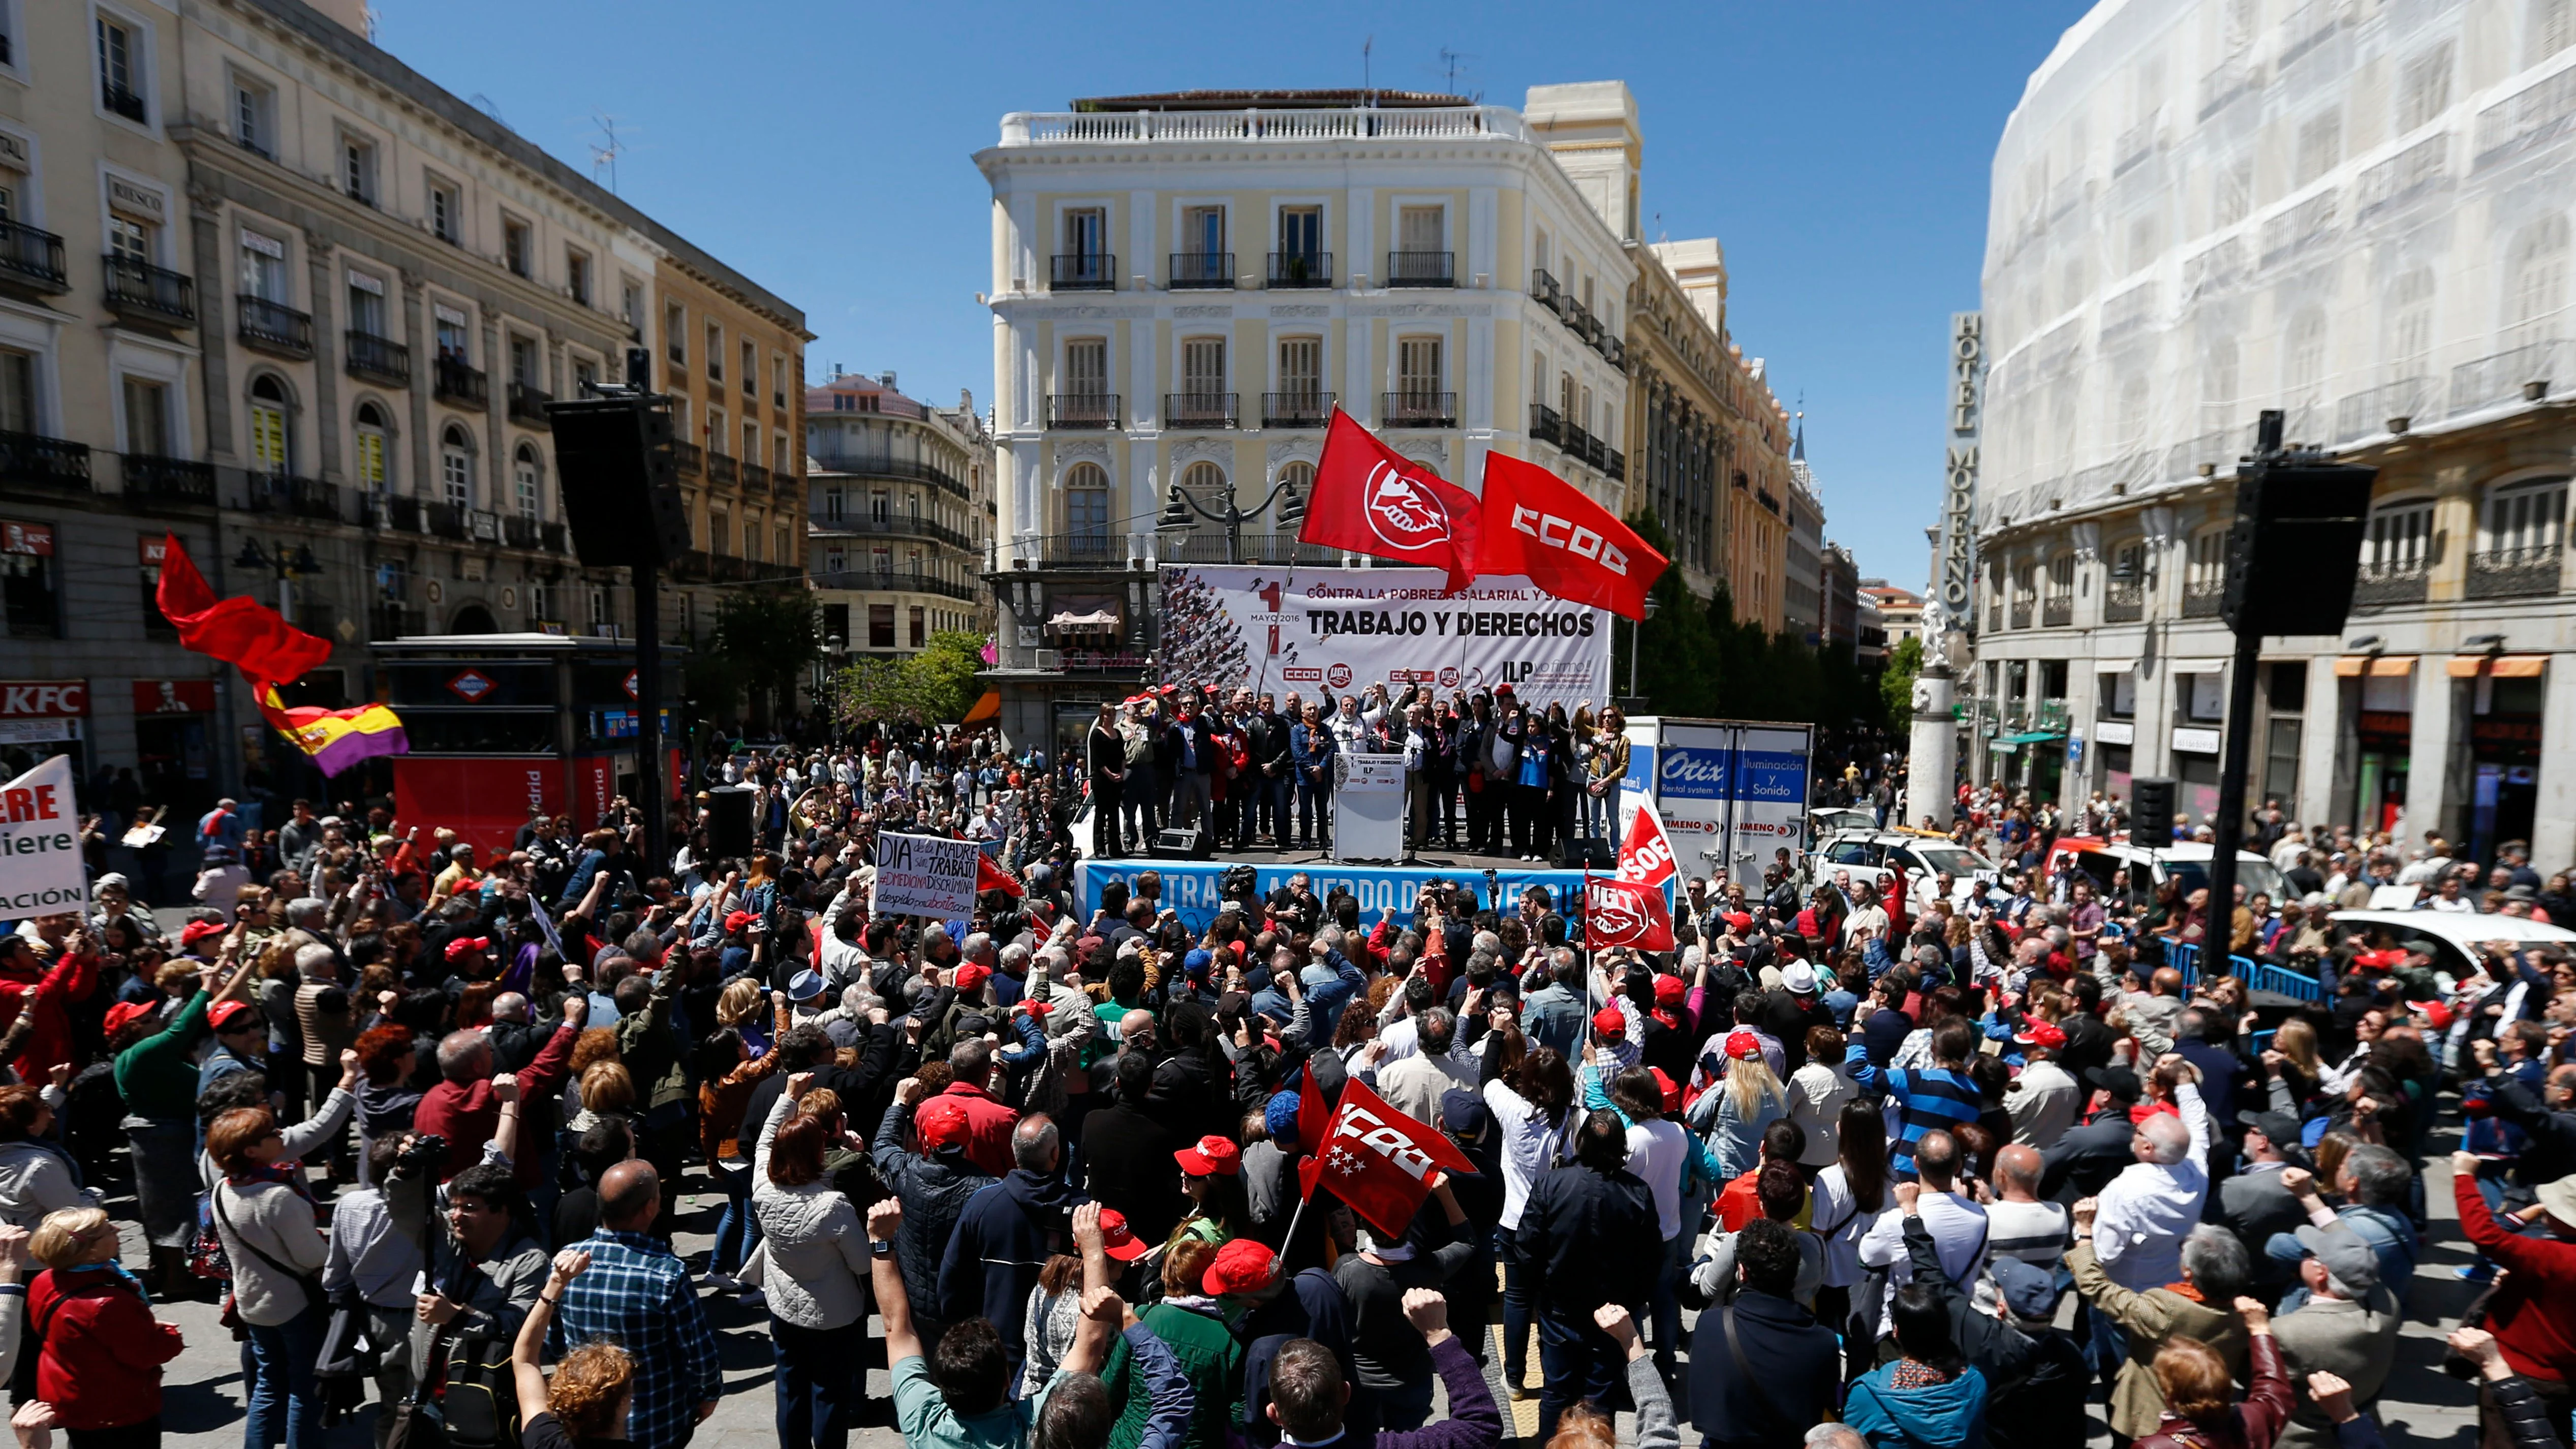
[2218,459,2378,634]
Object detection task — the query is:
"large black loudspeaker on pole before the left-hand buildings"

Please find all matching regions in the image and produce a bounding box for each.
[546,397,688,567]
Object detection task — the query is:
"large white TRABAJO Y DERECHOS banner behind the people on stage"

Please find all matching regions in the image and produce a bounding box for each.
[1159,565,1612,712]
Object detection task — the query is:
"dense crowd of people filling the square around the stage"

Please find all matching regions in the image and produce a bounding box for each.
[0,717,2576,1449]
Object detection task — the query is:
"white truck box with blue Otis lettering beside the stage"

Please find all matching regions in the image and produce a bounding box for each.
[1612,714,1814,895]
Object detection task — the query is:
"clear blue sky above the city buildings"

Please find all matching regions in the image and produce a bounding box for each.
[376,0,2087,588]
